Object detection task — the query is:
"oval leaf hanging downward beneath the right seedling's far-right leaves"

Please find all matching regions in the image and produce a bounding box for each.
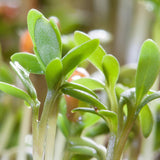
[139,105,153,138]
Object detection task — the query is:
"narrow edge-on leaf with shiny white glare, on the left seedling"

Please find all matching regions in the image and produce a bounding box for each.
[10,61,37,99]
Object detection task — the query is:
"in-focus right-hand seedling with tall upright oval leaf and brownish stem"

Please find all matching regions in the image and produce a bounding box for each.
[61,32,160,160]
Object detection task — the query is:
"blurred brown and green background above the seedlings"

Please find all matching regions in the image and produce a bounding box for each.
[0,0,160,64]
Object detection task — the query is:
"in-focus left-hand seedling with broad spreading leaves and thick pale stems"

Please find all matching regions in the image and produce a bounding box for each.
[0,9,99,160]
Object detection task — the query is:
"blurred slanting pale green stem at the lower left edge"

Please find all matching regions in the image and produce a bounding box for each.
[0,111,16,154]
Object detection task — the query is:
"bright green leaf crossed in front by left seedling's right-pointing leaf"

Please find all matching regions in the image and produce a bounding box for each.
[74,31,106,71]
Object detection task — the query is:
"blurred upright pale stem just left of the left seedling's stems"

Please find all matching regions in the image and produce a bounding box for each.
[17,106,31,160]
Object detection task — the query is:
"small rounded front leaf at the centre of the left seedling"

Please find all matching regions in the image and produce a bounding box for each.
[45,58,63,89]
